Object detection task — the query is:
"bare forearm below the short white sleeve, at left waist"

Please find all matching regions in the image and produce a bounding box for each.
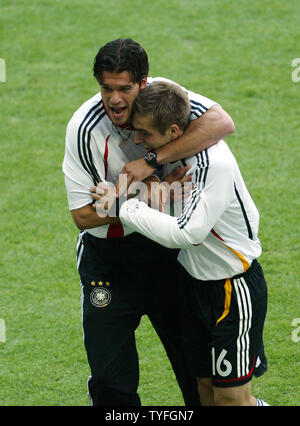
[71,204,120,230]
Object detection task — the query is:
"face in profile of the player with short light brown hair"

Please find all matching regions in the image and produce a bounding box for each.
[132,113,174,149]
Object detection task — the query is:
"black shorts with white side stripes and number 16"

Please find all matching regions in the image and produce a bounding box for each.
[180,260,267,387]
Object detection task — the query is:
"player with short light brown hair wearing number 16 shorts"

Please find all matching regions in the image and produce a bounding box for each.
[119,82,268,406]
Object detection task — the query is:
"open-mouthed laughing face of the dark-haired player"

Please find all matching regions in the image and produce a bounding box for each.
[100,71,147,126]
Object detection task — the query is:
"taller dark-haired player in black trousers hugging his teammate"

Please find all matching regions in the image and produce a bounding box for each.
[63,39,234,406]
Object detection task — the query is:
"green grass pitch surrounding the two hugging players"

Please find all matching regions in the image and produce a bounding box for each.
[0,0,300,406]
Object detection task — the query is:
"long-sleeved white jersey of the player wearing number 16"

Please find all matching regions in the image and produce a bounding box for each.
[120,141,261,281]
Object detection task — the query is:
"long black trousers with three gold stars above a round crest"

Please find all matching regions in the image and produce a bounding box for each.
[77,232,199,405]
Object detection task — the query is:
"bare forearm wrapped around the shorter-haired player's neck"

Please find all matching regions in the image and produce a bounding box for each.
[156,105,234,164]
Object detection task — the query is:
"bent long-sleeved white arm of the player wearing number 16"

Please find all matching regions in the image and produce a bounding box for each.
[119,166,234,248]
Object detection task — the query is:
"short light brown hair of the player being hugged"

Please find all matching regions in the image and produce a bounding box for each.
[133,81,191,135]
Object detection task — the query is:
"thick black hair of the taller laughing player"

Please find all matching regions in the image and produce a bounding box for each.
[93,38,149,84]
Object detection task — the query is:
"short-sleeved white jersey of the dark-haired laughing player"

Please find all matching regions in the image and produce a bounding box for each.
[63,77,216,238]
